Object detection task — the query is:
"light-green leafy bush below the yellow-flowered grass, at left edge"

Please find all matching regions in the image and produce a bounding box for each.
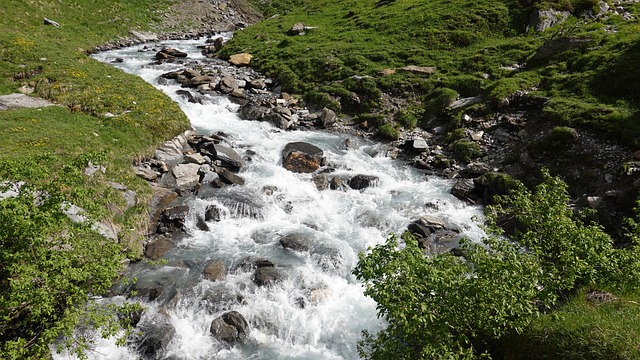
[0,158,132,359]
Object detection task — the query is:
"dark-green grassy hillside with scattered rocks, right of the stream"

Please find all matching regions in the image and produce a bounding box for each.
[223,0,640,142]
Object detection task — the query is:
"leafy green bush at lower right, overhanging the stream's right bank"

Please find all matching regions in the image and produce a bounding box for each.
[354,172,640,359]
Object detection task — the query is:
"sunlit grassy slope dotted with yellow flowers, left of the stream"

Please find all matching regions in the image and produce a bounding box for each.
[0,0,188,250]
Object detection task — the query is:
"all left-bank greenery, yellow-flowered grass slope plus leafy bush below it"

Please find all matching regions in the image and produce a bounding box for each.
[0,0,189,359]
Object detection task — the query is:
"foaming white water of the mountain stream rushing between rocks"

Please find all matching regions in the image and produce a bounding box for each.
[54,35,482,359]
